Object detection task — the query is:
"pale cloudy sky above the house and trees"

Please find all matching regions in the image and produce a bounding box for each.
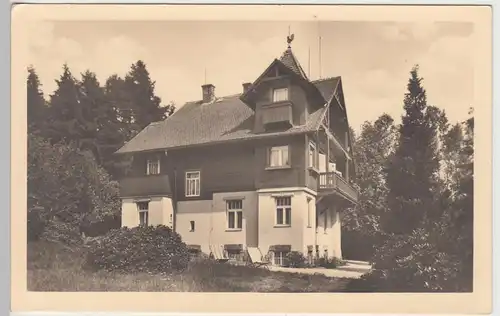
[26,21,474,131]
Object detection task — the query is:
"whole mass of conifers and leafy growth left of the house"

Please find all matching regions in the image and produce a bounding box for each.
[27,61,174,240]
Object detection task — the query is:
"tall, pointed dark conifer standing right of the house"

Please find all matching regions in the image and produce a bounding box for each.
[384,66,442,235]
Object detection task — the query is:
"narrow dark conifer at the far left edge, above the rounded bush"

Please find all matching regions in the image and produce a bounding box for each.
[27,66,47,132]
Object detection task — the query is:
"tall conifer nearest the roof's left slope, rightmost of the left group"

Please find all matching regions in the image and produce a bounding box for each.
[125,60,175,132]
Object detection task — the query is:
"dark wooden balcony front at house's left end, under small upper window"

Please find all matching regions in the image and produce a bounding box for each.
[120,174,172,197]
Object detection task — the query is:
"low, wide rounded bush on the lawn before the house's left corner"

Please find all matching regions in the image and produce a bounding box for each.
[85,225,189,273]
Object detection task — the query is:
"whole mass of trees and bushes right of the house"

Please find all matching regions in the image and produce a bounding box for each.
[350,67,474,292]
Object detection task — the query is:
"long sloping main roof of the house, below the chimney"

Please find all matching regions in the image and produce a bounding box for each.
[117,77,338,154]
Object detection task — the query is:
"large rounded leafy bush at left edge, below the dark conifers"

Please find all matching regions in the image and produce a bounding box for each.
[27,134,120,240]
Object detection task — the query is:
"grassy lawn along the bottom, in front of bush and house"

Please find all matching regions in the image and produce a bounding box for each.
[27,242,349,292]
